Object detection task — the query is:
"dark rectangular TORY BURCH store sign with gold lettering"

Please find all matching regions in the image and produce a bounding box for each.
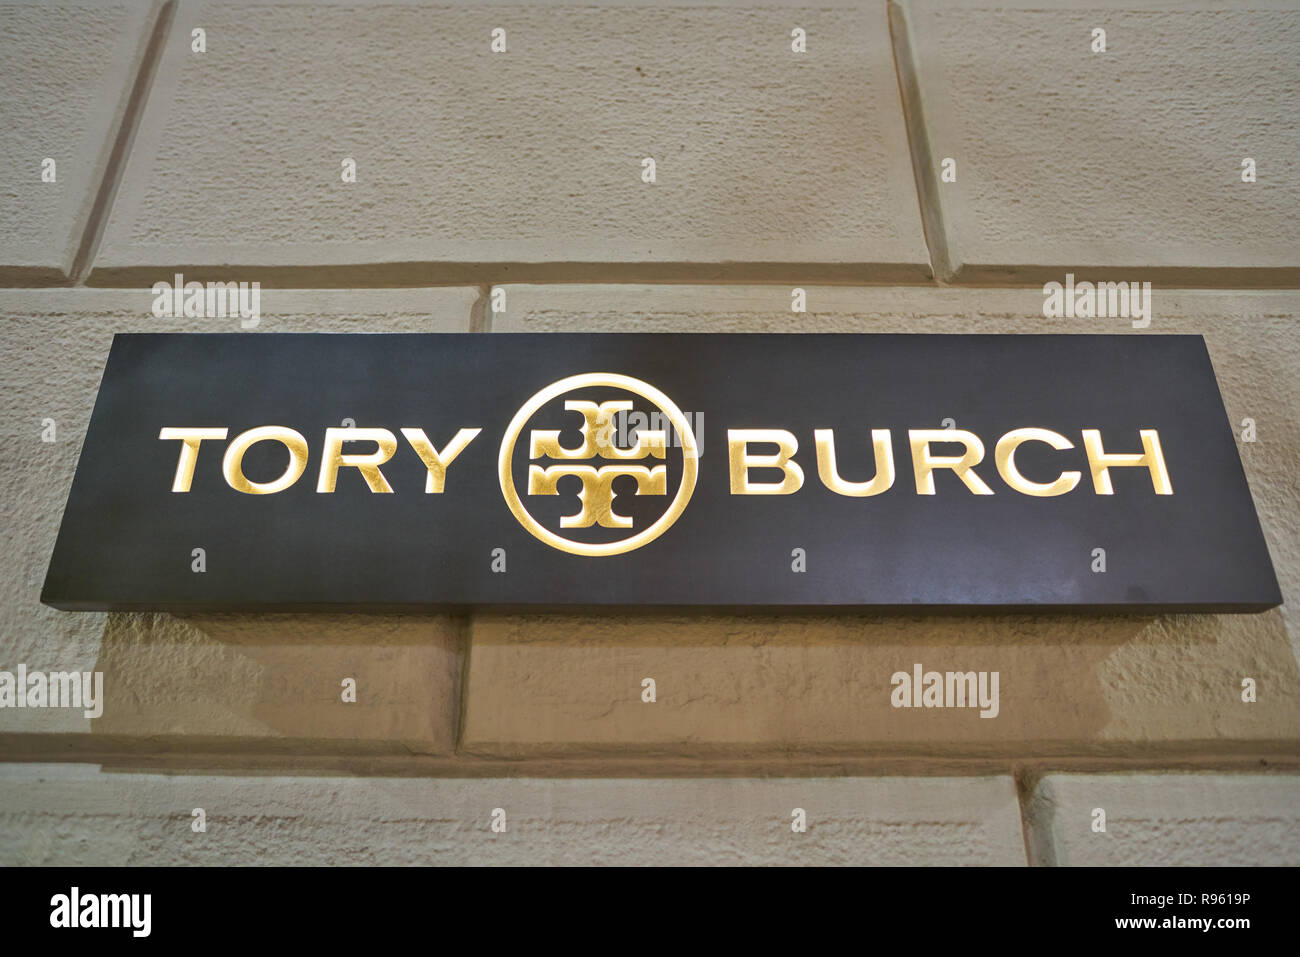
[42,334,1281,611]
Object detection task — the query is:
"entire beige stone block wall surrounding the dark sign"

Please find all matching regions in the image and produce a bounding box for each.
[0,0,1300,865]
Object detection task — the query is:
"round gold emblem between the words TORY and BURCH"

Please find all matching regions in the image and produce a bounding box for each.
[498,372,699,558]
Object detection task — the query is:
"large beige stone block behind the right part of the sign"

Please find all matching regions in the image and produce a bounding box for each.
[462,286,1300,761]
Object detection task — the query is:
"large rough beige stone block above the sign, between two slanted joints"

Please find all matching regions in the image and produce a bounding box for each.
[91,0,930,285]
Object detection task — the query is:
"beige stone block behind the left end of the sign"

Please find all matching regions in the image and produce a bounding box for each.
[0,289,477,753]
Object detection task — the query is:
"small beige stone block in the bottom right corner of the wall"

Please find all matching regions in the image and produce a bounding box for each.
[1027,774,1300,867]
